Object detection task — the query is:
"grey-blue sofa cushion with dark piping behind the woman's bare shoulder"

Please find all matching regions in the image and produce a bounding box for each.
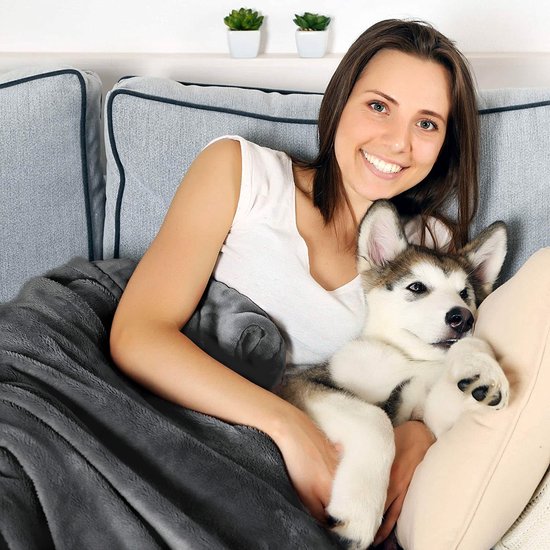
[104,78,321,259]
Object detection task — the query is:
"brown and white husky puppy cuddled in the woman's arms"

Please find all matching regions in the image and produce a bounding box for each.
[281,200,509,548]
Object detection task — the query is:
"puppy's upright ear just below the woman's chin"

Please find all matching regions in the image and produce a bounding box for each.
[357,200,408,273]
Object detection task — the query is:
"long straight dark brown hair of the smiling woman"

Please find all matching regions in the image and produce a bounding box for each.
[309,19,479,248]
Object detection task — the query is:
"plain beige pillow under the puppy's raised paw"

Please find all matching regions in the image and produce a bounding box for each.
[397,248,550,550]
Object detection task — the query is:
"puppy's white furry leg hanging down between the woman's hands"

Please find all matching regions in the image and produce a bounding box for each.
[307,392,395,548]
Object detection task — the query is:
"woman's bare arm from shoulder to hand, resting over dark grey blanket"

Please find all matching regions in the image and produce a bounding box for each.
[111,140,338,520]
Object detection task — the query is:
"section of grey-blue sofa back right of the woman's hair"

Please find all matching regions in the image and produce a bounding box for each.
[472,88,550,282]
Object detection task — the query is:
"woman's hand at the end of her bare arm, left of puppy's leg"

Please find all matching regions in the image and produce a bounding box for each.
[270,405,341,523]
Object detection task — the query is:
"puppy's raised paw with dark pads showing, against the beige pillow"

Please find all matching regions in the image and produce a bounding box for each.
[449,338,510,410]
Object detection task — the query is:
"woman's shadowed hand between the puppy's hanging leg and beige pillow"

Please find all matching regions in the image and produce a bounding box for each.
[374,420,435,546]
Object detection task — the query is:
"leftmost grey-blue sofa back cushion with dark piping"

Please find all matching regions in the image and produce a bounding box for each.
[0,68,104,301]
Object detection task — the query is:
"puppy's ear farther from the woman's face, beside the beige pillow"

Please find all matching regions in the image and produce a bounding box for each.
[459,222,508,300]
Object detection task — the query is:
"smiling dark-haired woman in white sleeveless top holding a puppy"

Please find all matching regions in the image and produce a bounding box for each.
[111,20,478,542]
